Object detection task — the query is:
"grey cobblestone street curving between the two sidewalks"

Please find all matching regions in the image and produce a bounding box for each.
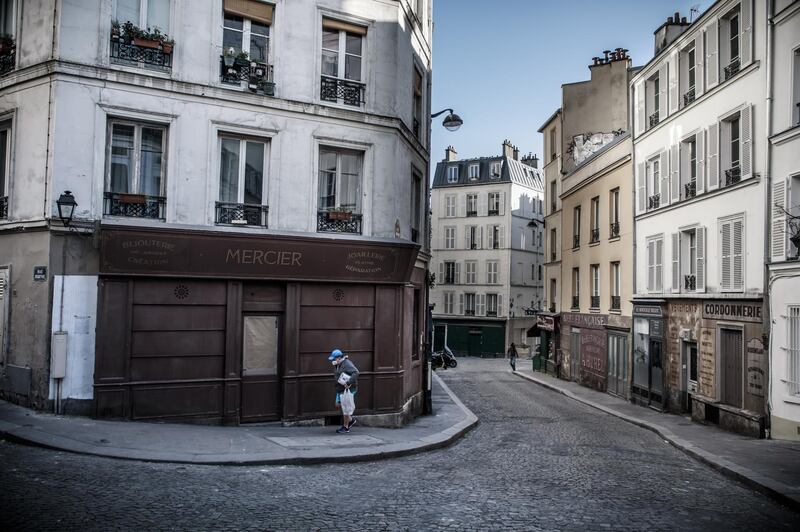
[0,359,800,531]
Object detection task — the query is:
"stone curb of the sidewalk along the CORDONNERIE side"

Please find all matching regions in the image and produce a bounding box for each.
[513,371,800,512]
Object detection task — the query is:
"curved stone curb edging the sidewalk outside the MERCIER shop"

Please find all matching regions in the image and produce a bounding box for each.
[0,374,478,465]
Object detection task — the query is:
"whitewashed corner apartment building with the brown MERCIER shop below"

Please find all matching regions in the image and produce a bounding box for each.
[0,0,432,425]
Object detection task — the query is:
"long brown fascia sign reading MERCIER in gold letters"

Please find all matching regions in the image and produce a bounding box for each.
[100,228,419,283]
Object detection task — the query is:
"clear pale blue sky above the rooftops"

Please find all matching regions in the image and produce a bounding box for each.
[431,0,713,170]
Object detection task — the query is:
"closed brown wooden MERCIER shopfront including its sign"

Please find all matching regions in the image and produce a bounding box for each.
[95,228,426,424]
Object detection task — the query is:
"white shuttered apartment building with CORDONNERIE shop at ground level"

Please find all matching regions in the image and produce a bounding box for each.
[630,0,769,436]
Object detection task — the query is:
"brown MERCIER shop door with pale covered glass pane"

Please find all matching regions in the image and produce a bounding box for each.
[241,315,282,422]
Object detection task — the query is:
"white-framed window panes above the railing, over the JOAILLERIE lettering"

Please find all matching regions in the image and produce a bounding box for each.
[319,147,363,213]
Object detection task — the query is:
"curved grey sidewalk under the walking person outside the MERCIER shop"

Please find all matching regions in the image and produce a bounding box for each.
[0,374,478,465]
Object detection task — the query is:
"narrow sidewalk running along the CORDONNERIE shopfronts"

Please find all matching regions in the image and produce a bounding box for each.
[515,359,800,510]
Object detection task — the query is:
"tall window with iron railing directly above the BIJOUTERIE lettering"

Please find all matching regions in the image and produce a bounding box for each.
[104,120,167,219]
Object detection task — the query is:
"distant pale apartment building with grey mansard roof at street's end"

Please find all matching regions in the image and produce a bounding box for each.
[430,141,544,356]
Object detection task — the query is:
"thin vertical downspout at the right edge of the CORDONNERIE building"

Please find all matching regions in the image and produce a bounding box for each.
[762,0,775,438]
